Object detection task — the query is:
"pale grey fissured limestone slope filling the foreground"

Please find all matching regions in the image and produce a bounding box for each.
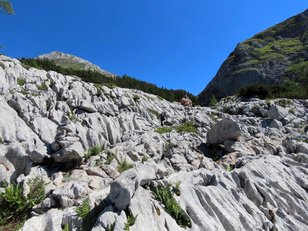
[0,56,308,231]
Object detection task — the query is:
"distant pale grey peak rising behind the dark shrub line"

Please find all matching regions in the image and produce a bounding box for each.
[38,51,115,77]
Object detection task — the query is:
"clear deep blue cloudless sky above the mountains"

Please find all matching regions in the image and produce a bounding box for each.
[0,0,308,94]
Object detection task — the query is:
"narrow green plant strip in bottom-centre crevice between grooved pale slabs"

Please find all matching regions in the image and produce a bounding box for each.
[153,185,191,228]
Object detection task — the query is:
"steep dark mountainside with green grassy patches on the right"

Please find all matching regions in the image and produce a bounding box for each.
[198,10,308,105]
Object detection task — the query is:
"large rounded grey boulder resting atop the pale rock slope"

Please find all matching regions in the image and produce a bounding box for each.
[206,118,241,144]
